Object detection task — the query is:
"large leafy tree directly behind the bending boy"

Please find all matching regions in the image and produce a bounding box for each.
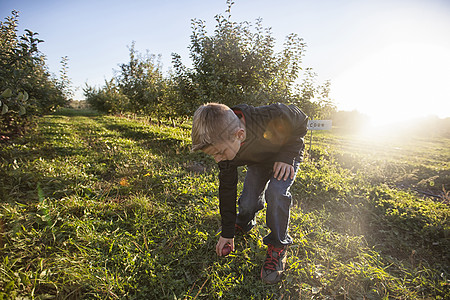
[173,1,305,113]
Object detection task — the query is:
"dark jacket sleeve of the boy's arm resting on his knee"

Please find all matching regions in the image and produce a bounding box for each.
[276,105,308,165]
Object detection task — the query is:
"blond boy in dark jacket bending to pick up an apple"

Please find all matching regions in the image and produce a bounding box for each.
[192,103,308,283]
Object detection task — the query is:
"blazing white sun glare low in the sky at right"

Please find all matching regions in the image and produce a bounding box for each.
[332,39,450,126]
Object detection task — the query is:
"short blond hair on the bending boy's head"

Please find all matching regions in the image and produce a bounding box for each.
[191,103,240,151]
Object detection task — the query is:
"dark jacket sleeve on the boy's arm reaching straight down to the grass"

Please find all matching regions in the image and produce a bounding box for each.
[219,162,238,238]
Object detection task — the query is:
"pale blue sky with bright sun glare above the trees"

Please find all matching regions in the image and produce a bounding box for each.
[0,0,450,124]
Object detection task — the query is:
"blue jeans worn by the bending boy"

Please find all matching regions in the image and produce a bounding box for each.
[236,162,299,247]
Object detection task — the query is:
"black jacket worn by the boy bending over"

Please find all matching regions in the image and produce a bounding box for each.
[219,103,308,238]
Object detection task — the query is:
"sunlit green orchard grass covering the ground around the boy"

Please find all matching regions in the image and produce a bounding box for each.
[0,110,450,299]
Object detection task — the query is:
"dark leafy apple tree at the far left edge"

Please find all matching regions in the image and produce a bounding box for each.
[0,11,67,139]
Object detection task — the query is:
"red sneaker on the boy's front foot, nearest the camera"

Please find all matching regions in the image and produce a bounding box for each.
[261,244,287,284]
